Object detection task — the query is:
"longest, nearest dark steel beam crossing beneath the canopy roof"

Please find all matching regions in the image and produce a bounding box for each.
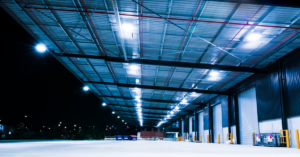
[55,53,268,73]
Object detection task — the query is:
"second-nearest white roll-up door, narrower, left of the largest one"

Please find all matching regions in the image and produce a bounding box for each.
[213,104,223,143]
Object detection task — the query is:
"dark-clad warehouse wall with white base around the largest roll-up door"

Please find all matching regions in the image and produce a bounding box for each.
[226,49,300,143]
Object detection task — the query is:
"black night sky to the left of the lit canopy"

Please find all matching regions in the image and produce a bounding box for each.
[0,7,129,130]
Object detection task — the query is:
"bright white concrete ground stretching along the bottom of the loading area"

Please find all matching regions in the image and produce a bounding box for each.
[0,141,300,157]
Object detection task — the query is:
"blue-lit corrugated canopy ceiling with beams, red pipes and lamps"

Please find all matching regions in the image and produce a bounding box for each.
[0,0,300,126]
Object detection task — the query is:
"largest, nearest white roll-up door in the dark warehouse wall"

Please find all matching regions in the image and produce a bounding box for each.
[238,88,259,145]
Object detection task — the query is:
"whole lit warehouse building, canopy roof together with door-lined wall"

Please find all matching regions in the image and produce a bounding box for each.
[0,0,300,151]
